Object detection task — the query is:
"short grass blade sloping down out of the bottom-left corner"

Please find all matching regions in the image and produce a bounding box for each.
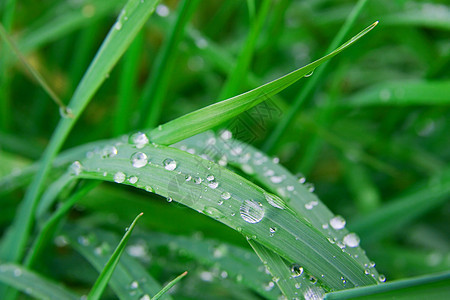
[0,264,80,300]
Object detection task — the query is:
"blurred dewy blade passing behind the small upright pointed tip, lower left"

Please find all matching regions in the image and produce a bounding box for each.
[62,226,172,300]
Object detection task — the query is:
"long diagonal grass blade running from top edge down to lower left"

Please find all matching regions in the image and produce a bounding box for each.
[0,0,158,268]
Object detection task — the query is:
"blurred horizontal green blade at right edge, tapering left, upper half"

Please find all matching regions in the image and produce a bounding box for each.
[339,80,450,107]
